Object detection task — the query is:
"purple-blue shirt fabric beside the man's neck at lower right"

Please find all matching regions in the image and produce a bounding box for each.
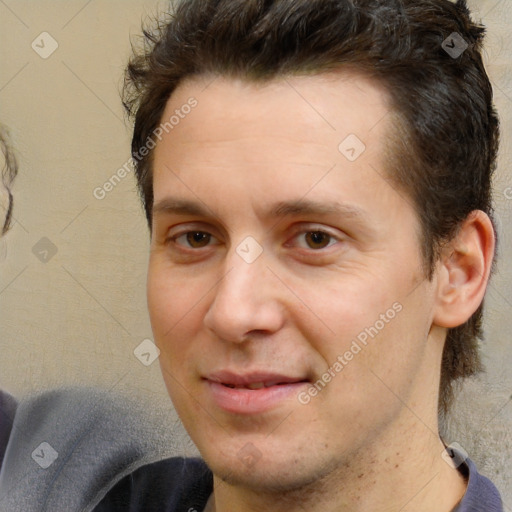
[456,459,503,512]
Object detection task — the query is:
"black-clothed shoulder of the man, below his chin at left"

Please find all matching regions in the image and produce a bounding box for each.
[94,457,213,512]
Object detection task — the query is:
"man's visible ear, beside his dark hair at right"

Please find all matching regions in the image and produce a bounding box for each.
[433,210,495,328]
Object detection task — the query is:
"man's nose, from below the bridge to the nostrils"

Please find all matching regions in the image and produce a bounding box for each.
[204,247,285,343]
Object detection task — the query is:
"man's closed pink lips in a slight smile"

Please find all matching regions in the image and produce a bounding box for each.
[204,371,309,414]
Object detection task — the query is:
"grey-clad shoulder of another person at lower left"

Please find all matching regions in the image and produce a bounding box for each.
[0,388,175,512]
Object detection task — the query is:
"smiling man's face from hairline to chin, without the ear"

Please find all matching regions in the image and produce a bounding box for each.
[148,73,439,489]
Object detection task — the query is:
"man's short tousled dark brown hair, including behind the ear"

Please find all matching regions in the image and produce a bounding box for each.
[123,0,499,413]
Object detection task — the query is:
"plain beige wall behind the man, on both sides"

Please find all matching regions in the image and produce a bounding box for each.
[0,0,512,504]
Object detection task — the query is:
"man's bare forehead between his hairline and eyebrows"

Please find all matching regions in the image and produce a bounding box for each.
[153,73,406,229]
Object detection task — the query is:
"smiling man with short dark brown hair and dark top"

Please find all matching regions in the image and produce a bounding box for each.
[97,0,503,512]
